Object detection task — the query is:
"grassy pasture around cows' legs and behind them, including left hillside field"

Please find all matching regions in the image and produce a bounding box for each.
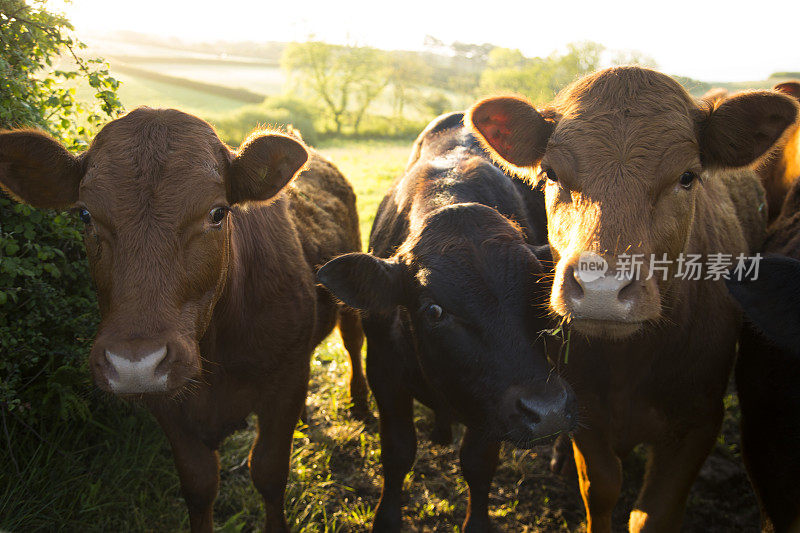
[0,28,792,532]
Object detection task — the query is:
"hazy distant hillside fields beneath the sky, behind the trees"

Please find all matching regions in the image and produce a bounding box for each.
[73,32,800,127]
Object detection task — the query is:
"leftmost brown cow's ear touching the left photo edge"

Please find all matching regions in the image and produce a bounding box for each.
[0,130,84,208]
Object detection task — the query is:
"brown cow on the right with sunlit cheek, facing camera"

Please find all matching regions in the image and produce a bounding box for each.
[470,67,797,532]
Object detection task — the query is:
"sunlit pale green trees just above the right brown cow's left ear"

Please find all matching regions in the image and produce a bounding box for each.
[480,41,603,103]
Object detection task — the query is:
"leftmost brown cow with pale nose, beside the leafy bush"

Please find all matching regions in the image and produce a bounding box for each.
[0,108,366,531]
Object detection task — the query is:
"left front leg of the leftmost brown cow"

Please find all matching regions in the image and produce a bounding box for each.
[154,422,219,533]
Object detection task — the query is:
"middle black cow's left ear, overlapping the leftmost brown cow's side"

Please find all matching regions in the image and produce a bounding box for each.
[317,253,402,314]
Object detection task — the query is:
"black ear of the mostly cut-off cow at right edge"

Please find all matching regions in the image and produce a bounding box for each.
[726,256,800,351]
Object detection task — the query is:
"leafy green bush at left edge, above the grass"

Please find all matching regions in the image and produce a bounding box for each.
[0,0,121,423]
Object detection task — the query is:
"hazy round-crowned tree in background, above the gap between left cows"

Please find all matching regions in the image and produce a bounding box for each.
[281,41,389,134]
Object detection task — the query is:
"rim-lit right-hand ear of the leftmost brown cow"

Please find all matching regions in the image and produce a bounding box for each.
[227,133,308,204]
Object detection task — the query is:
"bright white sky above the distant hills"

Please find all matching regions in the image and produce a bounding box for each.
[53,0,800,81]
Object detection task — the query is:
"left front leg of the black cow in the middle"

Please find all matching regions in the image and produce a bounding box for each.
[365,323,417,532]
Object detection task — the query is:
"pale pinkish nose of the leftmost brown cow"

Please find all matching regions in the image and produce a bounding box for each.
[105,346,169,394]
